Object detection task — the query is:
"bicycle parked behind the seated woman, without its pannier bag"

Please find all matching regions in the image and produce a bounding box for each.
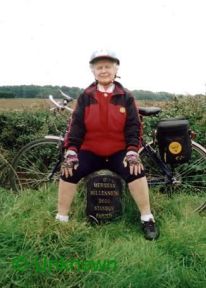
[10,94,206,193]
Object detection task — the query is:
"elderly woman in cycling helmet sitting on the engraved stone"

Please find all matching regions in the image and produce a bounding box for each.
[56,50,159,240]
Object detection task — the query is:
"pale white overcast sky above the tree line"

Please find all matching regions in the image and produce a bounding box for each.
[0,0,206,94]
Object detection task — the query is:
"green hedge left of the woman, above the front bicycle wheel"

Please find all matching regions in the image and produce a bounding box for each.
[0,111,68,159]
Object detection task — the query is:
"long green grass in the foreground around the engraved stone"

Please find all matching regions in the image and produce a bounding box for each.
[0,187,206,288]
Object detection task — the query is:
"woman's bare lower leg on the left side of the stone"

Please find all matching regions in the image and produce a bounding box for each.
[58,179,77,215]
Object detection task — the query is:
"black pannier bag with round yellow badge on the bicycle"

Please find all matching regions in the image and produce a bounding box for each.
[157,118,192,164]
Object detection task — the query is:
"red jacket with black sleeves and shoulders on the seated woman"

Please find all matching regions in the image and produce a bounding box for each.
[64,82,142,156]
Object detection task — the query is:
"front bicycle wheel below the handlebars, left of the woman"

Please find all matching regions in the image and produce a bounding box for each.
[10,136,62,191]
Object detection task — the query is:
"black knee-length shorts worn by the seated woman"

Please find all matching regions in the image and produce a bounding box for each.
[61,150,145,183]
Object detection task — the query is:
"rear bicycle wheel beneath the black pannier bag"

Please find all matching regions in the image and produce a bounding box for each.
[140,141,206,192]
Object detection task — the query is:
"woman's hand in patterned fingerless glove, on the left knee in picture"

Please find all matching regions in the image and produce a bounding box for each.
[61,150,79,177]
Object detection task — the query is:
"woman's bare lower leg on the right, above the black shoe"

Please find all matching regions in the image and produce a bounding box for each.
[128,177,151,215]
